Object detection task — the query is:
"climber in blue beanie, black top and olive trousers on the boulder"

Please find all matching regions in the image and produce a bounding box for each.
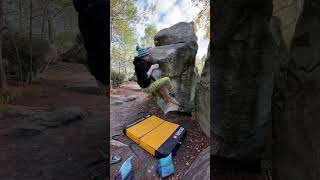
[133,46,180,113]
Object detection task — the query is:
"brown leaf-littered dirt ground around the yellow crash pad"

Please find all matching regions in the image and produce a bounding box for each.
[110,82,209,180]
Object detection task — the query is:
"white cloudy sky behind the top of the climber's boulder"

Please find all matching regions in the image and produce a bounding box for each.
[136,0,209,58]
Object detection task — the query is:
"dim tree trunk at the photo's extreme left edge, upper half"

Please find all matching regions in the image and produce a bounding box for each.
[0,1,7,92]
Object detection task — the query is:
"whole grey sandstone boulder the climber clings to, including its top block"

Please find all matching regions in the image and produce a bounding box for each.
[149,22,198,112]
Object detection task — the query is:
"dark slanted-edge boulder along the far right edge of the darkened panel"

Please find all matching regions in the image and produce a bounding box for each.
[273,0,320,180]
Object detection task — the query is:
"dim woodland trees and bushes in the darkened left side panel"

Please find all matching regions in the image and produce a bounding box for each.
[3,0,78,85]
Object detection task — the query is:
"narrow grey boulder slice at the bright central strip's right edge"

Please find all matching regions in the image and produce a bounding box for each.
[195,45,211,137]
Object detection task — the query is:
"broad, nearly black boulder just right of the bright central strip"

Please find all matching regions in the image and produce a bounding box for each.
[210,0,275,160]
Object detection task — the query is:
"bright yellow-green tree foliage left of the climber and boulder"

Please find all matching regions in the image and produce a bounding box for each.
[110,0,154,75]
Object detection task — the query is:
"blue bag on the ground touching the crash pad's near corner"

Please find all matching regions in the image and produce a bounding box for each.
[157,153,174,178]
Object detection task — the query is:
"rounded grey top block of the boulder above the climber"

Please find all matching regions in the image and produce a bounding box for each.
[154,22,197,46]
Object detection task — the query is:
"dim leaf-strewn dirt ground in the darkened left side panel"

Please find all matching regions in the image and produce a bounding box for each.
[0,63,109,180]
